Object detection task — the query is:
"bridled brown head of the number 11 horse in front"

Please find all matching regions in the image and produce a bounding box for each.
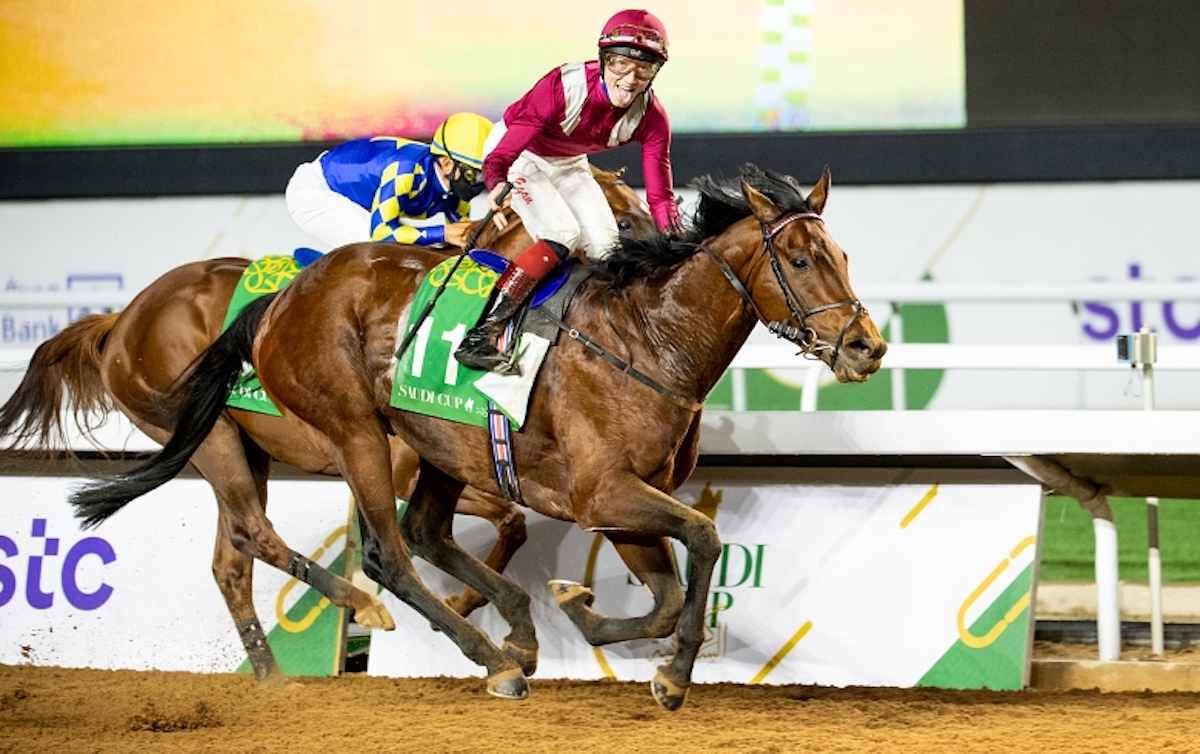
[740,166,887,382]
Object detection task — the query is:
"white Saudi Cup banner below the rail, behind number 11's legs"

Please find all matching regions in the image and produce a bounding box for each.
[368,482,1042,689]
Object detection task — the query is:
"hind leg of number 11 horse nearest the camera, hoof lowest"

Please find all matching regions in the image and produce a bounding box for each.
[343,437,529,699]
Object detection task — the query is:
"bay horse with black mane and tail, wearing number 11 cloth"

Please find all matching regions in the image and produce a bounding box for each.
[63,166,887,710]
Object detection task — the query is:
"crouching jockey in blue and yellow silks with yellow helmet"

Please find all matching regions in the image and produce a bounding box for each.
[287,113,492,247]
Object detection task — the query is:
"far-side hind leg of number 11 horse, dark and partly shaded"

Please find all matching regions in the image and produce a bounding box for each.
[401,462,538,675]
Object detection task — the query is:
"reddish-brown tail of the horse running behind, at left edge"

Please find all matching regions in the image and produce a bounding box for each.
[0,312,120,456]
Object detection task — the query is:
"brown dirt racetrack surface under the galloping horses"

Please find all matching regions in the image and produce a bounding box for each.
[0,648,1200,754]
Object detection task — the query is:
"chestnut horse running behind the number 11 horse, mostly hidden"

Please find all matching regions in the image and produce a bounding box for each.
[0,168,654,686]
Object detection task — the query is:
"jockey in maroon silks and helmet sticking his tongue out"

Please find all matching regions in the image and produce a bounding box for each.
[455,10,679,373]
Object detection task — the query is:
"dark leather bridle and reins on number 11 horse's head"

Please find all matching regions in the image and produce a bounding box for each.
[700,210,866,365]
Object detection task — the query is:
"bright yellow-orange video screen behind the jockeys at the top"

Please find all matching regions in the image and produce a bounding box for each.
[0,0,966,148]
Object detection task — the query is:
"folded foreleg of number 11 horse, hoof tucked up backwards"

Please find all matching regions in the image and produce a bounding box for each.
[550,532,683,646]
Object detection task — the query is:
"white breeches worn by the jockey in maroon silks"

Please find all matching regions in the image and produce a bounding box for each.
[490,124,618,259]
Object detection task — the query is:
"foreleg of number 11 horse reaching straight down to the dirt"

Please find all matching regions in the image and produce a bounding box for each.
[576,474,721,710]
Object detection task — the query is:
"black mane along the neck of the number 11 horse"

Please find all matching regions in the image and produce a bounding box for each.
[595,162,809,288]
